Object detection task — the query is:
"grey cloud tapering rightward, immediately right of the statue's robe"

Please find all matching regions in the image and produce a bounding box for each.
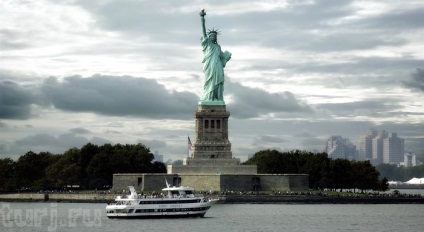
[225,80,313,118]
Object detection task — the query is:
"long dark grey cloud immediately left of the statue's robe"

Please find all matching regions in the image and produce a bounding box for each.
[42,75,197,118]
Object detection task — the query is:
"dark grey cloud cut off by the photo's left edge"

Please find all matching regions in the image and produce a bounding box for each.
[0,80,44,119]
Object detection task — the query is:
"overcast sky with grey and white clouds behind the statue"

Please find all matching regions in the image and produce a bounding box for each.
[0,0,424,161]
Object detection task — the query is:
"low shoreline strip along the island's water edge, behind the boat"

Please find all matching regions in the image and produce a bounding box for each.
[0,192,424,204]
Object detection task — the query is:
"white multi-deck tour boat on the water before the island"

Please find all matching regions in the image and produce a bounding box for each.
[106,183,218,218]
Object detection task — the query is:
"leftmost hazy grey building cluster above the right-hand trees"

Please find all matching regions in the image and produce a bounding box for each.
[325,136,356,160]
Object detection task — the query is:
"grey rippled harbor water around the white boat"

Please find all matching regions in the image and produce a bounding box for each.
[0,202,424,232]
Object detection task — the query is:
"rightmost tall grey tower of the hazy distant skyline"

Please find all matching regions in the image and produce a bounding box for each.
[383,133,405,164]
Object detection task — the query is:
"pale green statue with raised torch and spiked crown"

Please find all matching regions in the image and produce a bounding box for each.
[199,9,231,105]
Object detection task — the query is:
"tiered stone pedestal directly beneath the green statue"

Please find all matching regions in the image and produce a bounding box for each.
[168,102,257,174]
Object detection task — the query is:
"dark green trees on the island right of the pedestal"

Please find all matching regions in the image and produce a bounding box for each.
[243,150,388,191]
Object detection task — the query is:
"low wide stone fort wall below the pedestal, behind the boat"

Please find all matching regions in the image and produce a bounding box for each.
[112,173,309,192]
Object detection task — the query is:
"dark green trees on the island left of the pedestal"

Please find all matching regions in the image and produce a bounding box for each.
[0,143,166,191]
